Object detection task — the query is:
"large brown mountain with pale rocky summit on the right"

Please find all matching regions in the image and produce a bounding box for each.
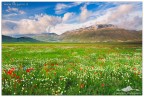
[60,24,142,42]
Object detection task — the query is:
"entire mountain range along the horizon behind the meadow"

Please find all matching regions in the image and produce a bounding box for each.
[2,24,142,43]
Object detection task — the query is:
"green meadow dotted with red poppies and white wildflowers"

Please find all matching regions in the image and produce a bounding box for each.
[1,43,142,95]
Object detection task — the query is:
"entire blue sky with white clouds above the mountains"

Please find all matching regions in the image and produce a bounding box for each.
[2,2,142,35]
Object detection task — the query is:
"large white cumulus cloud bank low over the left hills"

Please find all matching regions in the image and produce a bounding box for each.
[2,15,62,35]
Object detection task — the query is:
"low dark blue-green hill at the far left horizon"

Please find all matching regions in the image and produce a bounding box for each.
[2,35,40,42]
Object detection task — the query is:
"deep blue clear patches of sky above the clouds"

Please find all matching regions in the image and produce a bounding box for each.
[2,2,108,19]
